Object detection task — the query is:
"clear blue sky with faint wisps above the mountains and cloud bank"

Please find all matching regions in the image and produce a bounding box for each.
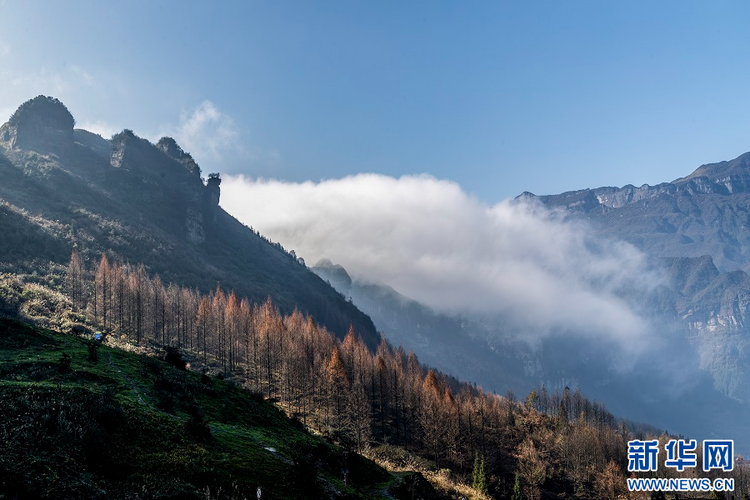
[0,0,750,204]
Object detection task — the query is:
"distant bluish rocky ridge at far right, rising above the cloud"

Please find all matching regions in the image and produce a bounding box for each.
[532,153,750,271]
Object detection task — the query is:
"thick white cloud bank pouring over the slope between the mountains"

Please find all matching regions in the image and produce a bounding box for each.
[221,174,658,349]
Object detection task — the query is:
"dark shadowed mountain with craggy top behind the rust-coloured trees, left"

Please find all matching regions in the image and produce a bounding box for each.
[0,96,380,348]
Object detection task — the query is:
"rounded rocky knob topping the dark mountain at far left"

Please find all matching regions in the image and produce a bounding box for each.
[0,95,75,157]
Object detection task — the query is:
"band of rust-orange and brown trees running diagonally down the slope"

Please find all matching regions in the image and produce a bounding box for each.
[66,252,748,499]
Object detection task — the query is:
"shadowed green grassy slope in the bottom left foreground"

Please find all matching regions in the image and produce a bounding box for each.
[0,318,390,499]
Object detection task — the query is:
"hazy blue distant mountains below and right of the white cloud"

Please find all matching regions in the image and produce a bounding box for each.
[313,153,750,450]
